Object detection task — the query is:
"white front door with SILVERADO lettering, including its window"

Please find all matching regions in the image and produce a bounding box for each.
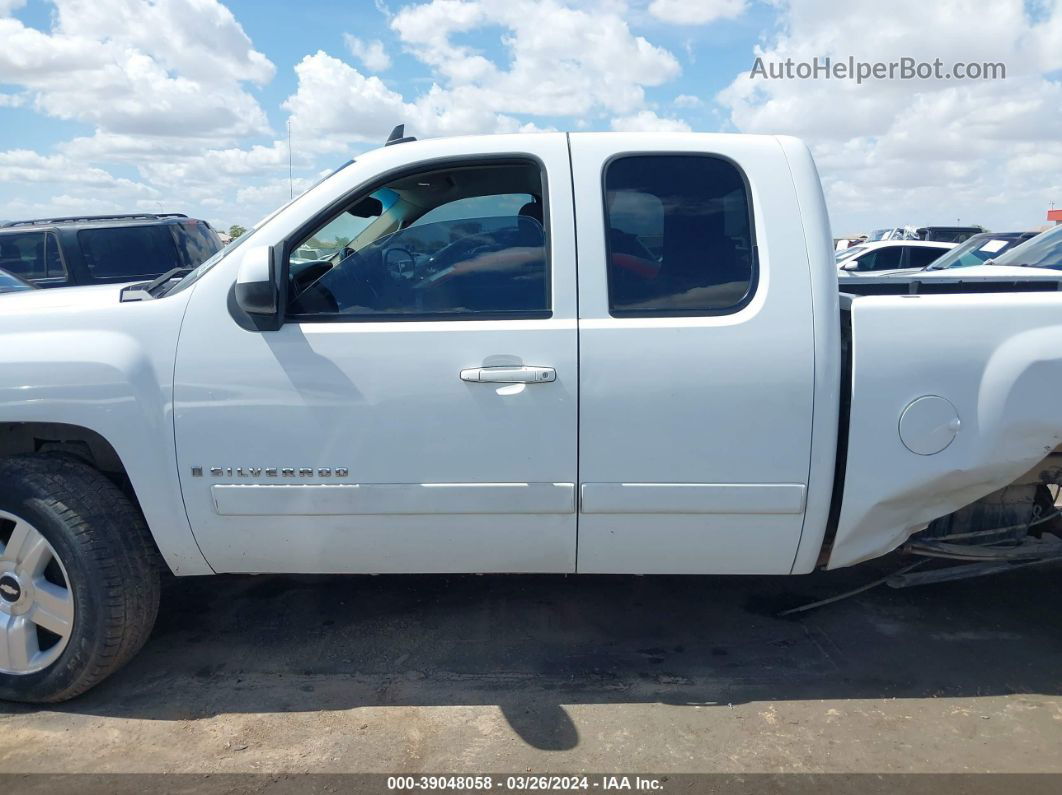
[175,135,578,572]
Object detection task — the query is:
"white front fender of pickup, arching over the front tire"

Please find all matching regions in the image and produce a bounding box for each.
[0,291,211,574]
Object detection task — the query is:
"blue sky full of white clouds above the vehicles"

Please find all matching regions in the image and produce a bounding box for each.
[0,0,1062,235]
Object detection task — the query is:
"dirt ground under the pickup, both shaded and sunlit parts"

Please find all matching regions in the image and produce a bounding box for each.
[0,561,1062,774]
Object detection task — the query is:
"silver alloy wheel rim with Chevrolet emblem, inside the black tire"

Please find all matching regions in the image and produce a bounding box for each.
[0,511,73,674]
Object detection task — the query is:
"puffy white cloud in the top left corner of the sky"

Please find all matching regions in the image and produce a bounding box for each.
[0,0,274,139]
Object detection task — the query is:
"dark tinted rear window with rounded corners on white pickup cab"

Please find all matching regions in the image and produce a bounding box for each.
[604,155,756,316]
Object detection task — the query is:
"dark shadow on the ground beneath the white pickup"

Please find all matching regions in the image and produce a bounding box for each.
[0,559,1062,750]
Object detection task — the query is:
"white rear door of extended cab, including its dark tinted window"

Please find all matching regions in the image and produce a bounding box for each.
[570,135,815,573]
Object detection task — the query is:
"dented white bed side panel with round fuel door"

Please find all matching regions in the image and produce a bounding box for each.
[828,293,1062,568]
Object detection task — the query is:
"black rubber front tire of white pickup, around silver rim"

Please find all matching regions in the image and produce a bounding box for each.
[0,454,159,703]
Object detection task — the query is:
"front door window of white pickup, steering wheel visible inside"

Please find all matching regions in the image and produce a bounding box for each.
[288,163,549,319]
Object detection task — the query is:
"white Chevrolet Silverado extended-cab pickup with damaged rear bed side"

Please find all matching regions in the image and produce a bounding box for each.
[0,133,1062,702]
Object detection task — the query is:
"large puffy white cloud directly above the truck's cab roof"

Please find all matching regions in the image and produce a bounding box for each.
[284,0,681,152]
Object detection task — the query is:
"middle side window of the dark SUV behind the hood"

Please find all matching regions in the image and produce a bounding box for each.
[78,226,184,279]
